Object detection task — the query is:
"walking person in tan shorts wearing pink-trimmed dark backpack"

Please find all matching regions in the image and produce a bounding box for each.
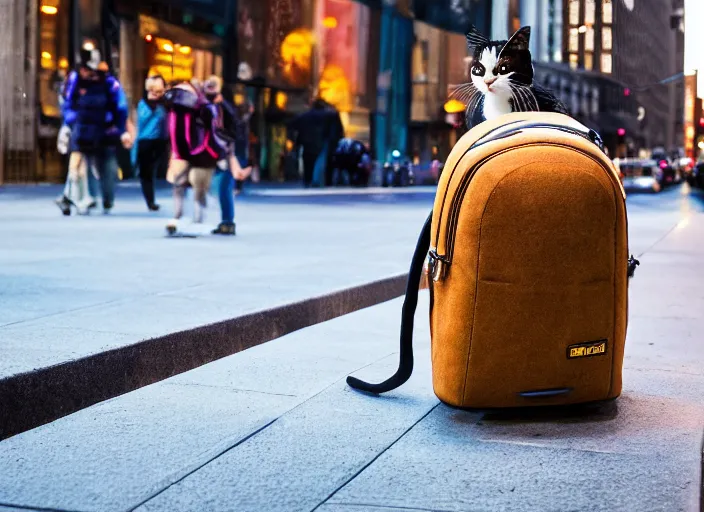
[166,82,227,235]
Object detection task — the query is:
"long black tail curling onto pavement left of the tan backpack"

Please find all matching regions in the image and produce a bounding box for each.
[347,212,433,393]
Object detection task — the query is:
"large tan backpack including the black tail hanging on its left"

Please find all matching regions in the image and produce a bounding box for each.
[347,112,638,409]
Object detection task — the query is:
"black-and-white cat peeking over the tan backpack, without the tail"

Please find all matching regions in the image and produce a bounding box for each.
[452,26,567,128]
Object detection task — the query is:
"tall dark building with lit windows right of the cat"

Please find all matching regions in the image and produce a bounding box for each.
[492,0,685,156]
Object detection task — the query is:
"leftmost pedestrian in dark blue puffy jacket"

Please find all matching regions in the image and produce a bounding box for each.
[57,50,132,215]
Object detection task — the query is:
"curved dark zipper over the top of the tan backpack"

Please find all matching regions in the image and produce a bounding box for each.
[428,138,625,282]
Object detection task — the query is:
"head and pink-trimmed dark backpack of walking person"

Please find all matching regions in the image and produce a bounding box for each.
[164,82,223,169]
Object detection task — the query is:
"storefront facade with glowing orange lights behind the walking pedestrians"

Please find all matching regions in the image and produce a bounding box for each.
[0,0,491,183]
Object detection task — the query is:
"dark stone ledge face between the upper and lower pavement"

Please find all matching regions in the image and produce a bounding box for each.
[0,274,427,440]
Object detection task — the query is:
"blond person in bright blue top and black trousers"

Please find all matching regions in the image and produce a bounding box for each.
[137,75,167,211]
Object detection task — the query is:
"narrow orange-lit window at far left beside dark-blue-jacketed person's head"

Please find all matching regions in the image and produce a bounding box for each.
[39,0,69,117]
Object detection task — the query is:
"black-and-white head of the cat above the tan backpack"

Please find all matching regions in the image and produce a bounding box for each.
[466,26,533,97]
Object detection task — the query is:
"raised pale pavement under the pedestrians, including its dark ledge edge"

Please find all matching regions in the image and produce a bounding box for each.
[0,184,433,439]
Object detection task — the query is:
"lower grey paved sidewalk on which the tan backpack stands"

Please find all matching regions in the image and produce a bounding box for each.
[0,186,704,512]
